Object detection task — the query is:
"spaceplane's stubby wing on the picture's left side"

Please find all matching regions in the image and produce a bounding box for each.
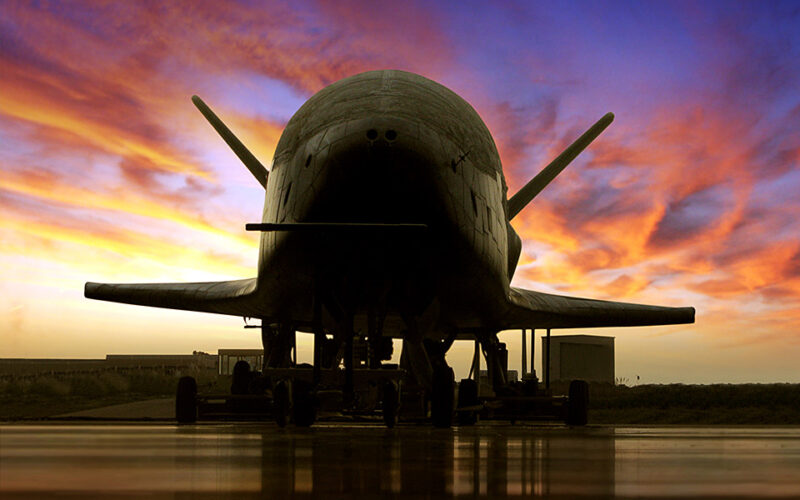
[83,278,259,317]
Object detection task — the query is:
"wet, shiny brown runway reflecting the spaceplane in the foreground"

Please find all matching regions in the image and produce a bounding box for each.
[0,424,800,499]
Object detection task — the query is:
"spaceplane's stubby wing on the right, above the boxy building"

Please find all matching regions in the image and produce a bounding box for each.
[504,287,694,329]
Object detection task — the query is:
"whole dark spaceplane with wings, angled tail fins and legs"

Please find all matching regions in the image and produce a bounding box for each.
[85,70,694,426]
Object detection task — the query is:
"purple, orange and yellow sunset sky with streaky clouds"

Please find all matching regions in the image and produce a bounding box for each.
[0,0,800,383]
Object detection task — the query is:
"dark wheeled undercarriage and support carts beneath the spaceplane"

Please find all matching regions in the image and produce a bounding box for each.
[175,327,589,428]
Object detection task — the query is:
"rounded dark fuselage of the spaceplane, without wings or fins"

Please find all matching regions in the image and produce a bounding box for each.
[253,71,520,335]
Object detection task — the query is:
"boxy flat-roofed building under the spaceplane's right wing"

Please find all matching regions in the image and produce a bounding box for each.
[542,335,614,384]
